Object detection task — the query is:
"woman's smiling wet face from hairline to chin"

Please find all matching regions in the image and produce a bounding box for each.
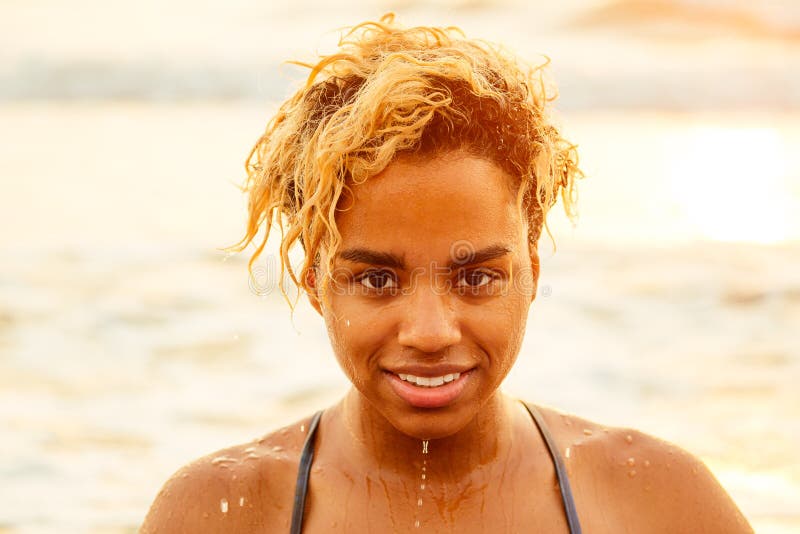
[312,152,538,439]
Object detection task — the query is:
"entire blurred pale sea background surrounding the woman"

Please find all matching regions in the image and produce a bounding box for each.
[0,0,800,534]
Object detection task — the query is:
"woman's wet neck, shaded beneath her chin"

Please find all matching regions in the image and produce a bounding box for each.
[323,388,519,482]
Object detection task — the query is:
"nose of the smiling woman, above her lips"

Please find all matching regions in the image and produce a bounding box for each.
[398,284,461,353]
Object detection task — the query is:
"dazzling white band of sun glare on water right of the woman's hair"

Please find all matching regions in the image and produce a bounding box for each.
[557,113,800,248]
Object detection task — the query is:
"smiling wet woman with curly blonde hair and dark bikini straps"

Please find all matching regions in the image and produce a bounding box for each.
[142,16,751,534]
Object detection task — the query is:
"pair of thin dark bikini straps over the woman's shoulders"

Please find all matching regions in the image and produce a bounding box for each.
[290,403,581,534]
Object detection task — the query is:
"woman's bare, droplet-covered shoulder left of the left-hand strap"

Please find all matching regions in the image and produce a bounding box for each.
[140,419,318,534]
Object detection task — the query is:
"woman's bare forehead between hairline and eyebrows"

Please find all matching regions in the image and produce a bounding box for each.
[337,152,527,261]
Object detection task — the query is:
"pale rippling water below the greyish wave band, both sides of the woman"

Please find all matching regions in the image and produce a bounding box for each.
[0,104,800,533]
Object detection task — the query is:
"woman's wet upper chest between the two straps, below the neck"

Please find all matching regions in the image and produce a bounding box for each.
[303,469,569,534]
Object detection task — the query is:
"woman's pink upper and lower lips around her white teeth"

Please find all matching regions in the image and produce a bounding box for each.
[385,366,472,408]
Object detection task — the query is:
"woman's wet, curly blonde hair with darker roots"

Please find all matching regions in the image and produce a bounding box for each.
[228,14,580,304]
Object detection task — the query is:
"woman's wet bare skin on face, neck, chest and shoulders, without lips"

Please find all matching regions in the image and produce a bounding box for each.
[141,152,752,534]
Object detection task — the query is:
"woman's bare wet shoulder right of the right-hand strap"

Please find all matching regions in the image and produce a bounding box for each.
[540,408,753,534]
